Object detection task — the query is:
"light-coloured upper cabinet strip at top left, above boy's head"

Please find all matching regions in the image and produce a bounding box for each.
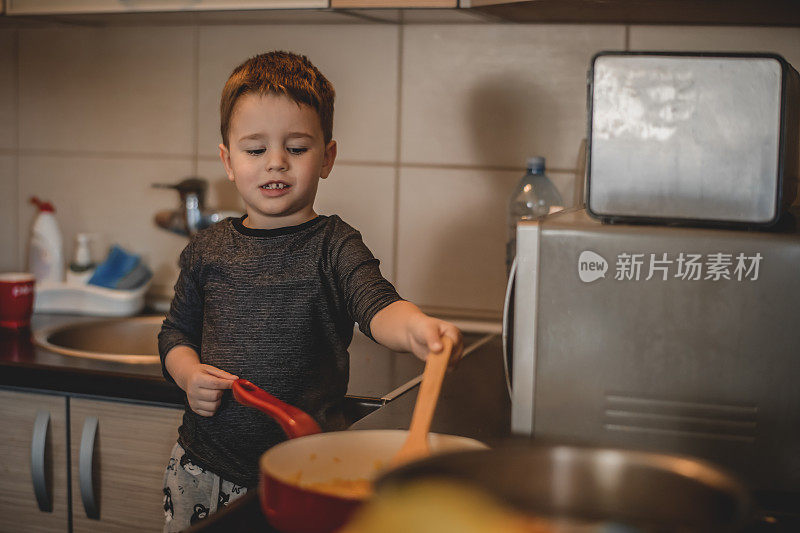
[6,0,328,15]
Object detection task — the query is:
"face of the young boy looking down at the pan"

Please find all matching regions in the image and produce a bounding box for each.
[219,93,336,229]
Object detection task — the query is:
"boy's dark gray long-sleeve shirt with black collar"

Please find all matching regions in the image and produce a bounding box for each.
[158,215,400,487]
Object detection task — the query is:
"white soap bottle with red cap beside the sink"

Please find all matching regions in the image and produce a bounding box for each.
[28,196,64,283]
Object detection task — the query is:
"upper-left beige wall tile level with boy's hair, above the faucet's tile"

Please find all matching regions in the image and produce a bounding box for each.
[19,27,195,155]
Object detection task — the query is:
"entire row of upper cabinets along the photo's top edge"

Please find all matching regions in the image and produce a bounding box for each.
[0,0,800,26]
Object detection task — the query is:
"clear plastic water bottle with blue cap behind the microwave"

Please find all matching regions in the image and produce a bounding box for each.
[506,157,564,272]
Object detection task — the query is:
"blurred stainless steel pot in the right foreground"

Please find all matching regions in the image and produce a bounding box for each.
[376,444,751,533]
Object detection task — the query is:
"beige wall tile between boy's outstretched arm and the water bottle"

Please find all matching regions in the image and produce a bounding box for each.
[397,168,521,316]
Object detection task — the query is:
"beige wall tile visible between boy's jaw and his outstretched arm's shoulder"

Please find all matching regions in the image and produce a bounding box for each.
[315,164,395,282]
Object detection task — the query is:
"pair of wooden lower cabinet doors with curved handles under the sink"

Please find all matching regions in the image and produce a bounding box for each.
[0,389,183,533]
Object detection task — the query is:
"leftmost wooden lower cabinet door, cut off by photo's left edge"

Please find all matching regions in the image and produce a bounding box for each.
[0,390,69,533]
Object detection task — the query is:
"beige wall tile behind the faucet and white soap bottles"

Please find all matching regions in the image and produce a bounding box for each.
[19,156,191,293]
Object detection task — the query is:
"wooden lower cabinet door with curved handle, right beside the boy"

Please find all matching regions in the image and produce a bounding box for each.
[70,398,183,533]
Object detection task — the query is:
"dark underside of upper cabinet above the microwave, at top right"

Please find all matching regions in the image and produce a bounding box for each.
[461,0,800,26]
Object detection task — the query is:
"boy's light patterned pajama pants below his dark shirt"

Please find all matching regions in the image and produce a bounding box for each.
[164,444,247,533]
